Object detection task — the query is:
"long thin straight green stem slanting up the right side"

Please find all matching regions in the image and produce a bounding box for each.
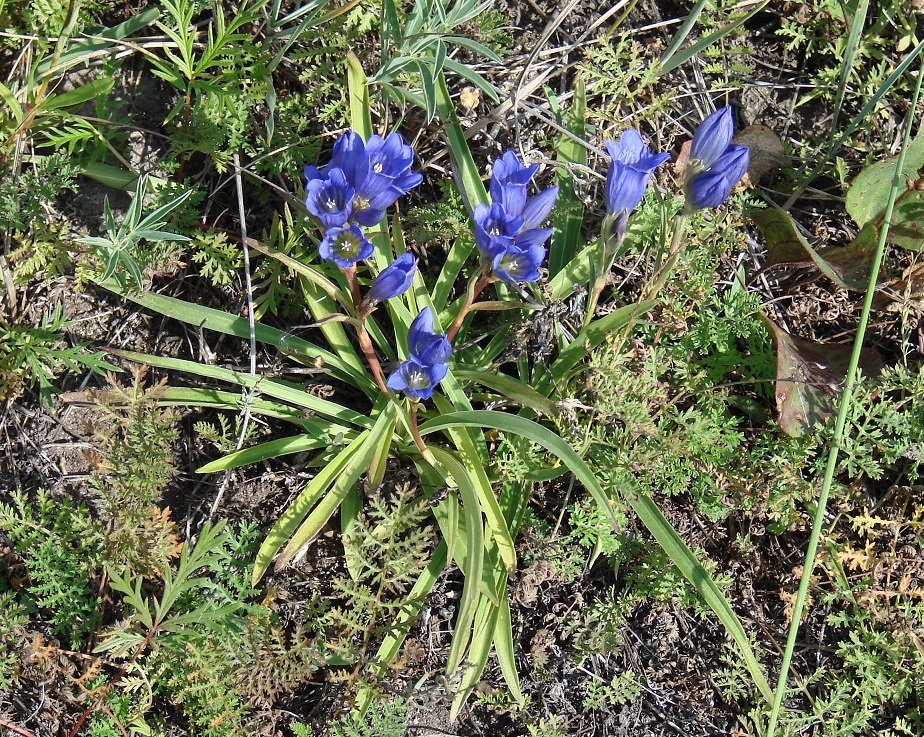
[767,59,924,737]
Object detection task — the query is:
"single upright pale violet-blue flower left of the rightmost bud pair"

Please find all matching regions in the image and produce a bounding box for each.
[606,129,670,237]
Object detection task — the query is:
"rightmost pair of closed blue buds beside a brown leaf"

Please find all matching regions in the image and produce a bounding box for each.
[684,106,750,209]
